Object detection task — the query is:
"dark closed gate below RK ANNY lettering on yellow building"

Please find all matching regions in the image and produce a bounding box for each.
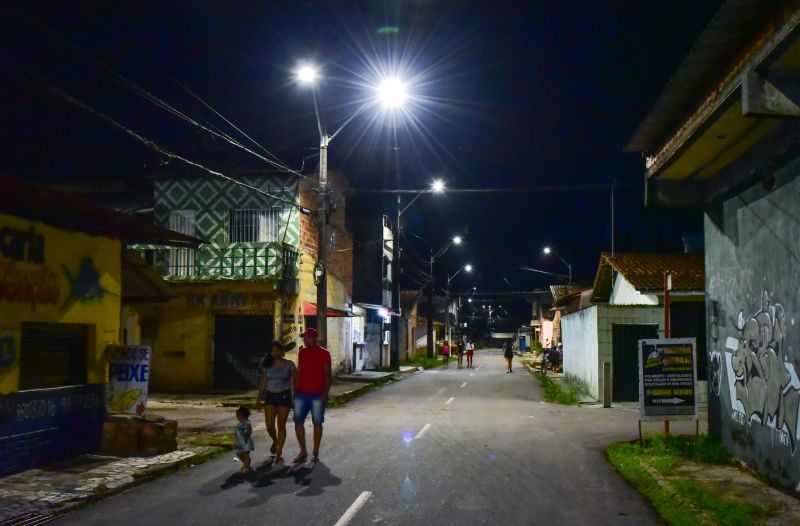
[214,314,274,389]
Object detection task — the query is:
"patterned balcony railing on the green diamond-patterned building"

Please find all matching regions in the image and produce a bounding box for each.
[140,243,298,281]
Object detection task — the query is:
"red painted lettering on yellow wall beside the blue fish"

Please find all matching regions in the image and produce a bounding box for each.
[0,260,61,310]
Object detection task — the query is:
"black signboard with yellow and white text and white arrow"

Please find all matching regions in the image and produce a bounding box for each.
[639,338,697,421]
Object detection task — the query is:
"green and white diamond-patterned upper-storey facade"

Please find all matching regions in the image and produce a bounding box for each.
[149,174,300,280]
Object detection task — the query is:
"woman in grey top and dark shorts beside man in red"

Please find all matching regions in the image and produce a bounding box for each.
[258,341,297,464]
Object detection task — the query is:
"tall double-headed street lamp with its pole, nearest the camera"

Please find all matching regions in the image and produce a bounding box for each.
[296,64,406,345]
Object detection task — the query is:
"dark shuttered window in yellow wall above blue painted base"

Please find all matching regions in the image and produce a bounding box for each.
[19,323,88,391]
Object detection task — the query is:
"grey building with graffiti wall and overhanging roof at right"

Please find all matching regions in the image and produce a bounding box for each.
[626,0,800,488]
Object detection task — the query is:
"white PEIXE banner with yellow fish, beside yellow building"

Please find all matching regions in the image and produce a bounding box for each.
[106,345,150,416]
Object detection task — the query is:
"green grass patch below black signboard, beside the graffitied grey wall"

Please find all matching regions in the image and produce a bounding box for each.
[606,435,776,526]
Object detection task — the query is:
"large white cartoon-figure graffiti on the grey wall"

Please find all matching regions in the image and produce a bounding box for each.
[711,292,800,453]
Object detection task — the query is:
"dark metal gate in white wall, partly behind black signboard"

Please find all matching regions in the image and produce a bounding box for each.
[611,323,658,402]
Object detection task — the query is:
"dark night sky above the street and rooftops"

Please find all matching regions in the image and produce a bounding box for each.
[0,0,719,324]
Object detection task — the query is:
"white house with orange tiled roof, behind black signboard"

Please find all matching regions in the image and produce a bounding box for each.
[554,252,707,402]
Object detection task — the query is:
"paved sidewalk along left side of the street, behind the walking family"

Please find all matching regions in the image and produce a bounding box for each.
[0,367,417,526]
